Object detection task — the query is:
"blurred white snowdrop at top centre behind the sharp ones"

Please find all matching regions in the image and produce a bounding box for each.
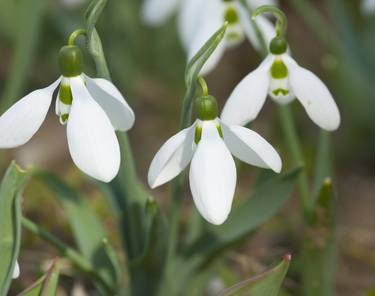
[178,0,275,74]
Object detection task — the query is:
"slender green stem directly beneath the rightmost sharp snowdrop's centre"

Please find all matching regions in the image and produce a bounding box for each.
[279,105,310,218]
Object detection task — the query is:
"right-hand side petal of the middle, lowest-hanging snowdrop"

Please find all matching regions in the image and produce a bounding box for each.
[221,123,281,173]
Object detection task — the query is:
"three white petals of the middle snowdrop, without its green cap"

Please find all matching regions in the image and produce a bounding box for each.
[148,118,281,225]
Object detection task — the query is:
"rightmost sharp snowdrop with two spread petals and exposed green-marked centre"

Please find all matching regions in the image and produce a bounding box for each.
[221,8,340,131]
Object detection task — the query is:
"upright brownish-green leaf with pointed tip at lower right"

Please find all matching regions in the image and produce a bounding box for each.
[301,178,336,296]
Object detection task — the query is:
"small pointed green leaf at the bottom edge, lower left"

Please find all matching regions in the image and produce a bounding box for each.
[18,260,60,296]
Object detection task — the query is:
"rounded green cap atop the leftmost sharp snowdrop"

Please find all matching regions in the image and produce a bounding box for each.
[59,45,83,77]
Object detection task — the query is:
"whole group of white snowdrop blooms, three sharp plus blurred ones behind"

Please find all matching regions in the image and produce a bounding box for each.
[0,0,340,231]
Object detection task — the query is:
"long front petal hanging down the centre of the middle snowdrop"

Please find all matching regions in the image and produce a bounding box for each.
[189,121,237,225]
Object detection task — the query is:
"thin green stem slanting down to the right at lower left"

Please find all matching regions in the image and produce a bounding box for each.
[21,217,112,291]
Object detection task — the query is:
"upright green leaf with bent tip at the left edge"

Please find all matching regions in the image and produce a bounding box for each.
[0,162,26,295]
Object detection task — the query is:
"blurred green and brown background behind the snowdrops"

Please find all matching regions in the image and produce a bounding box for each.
[0,0,375,295]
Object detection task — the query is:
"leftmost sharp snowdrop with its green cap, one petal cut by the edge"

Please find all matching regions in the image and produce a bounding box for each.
[0,35,134,182]
